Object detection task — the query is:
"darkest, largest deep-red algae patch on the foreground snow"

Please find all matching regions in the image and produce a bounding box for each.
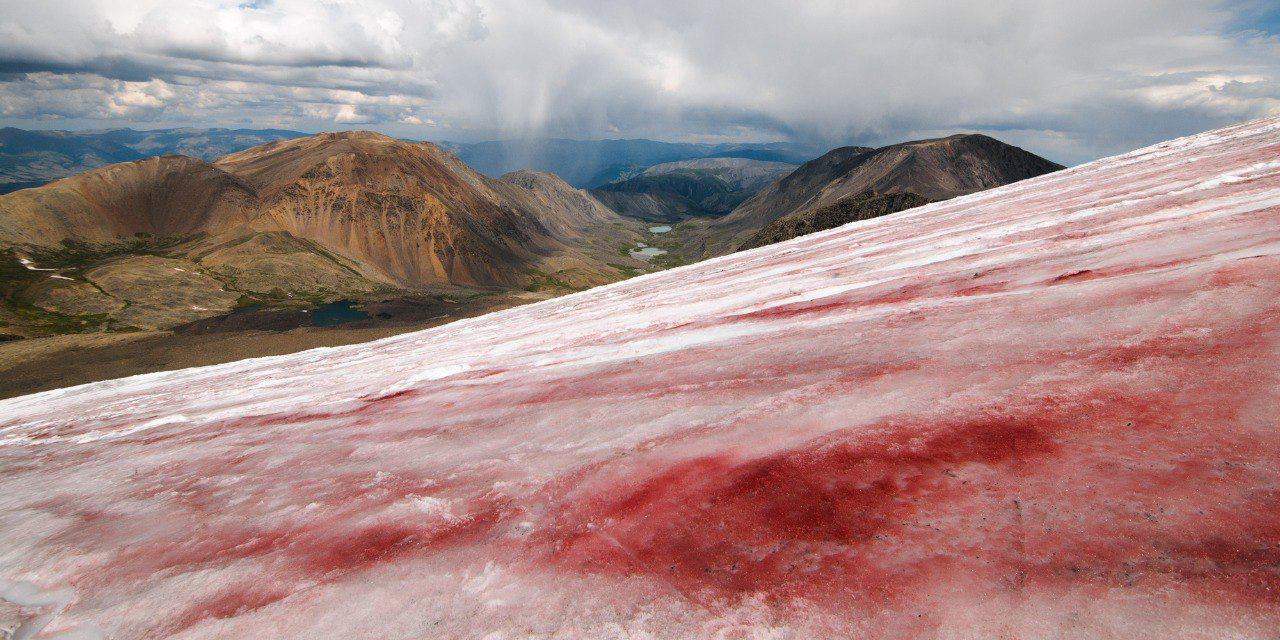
[550,421,1055,602]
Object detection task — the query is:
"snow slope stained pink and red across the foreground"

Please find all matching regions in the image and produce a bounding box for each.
[0,119,1280,639]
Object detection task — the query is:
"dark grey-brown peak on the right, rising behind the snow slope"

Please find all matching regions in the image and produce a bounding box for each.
[691,134,1062,256]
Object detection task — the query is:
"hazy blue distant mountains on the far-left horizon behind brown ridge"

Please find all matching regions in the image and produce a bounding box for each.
[0,127,306,193]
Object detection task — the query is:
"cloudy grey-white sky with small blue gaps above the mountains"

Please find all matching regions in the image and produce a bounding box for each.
[0,0,1280,164]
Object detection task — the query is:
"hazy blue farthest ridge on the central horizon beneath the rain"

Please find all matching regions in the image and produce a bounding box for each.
[439,138,822,188]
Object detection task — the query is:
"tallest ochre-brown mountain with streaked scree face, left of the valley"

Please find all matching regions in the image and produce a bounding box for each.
[218,132,637,285]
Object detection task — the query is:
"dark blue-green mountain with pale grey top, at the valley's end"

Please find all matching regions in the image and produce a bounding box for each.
[591,157,796,221]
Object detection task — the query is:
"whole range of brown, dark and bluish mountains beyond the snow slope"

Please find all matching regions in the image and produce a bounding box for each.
[0,129,1060,345]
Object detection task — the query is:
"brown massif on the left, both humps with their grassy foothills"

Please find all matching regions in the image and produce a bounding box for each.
[0,132,646,334]
